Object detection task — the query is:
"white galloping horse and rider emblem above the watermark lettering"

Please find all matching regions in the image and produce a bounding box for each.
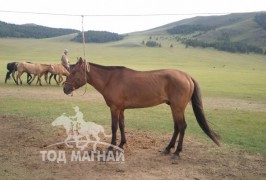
[50,106,112,151]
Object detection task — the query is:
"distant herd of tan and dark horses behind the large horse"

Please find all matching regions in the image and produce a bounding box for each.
[5,62,69,86]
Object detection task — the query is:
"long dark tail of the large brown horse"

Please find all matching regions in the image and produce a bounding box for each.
[191,78,220,146]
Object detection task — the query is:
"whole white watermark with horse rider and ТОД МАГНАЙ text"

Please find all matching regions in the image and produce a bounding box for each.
[40,106,125,163]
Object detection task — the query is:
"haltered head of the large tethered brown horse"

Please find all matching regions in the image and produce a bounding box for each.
[64,58,89,94]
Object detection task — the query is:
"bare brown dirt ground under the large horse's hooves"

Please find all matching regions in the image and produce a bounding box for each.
[0,115,266,179]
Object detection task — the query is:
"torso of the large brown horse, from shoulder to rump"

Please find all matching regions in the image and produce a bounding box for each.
[106,69,193,108]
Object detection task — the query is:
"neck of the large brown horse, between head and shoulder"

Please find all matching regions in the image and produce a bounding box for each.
[87,64,112,93]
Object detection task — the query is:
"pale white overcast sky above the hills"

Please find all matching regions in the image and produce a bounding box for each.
[0,0,266,34]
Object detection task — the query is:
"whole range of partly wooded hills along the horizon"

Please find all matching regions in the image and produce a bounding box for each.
[0,12,266,54]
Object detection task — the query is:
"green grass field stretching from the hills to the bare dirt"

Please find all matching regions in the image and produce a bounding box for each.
[0,34,266,156]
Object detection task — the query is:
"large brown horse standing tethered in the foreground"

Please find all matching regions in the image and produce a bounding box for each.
[64,58,220,159]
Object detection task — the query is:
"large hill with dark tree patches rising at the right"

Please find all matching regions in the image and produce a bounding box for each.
[141,12,266,50]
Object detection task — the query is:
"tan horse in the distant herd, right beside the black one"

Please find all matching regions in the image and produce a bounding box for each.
[17,62,54,86]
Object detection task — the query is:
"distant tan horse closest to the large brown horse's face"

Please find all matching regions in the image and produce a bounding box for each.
[45,64,70,85]
